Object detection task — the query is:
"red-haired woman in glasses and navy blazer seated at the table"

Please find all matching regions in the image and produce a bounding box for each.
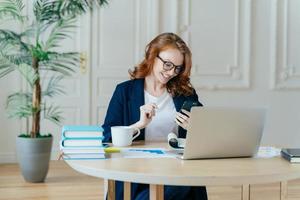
[102,33,207,200]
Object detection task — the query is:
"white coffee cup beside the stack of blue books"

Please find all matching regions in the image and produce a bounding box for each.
[111,126,141,147]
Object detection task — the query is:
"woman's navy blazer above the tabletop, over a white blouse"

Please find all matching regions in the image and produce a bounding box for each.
[102,79,202,142]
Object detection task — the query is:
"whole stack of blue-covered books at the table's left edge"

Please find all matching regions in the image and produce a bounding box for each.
[60,126,105,160]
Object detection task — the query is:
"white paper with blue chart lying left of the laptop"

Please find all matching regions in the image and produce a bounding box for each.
[115,148,176,158]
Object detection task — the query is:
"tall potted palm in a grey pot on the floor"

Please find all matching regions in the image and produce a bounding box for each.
[0,0,107,182]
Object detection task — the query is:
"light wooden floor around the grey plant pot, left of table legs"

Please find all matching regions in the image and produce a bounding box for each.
[0,161,103,200]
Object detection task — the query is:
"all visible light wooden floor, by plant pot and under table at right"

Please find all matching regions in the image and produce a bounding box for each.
[0,161,300,200]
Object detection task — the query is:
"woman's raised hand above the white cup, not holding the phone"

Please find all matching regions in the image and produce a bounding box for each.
[133,103,157,129]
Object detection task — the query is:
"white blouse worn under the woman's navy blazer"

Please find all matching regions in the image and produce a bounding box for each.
[144,91,178,141]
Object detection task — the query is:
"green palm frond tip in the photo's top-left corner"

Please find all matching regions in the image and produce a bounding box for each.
[0,0,26,22]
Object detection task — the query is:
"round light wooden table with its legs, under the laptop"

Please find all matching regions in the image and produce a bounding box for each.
[66,143,300,200]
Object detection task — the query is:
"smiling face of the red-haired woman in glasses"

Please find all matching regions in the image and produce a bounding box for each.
[152,48,184,85]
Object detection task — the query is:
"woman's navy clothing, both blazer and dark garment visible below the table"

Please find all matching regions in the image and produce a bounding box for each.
[102,79,207,200]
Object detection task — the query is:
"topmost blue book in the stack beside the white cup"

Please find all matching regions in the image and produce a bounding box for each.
[62,125,103,140]
